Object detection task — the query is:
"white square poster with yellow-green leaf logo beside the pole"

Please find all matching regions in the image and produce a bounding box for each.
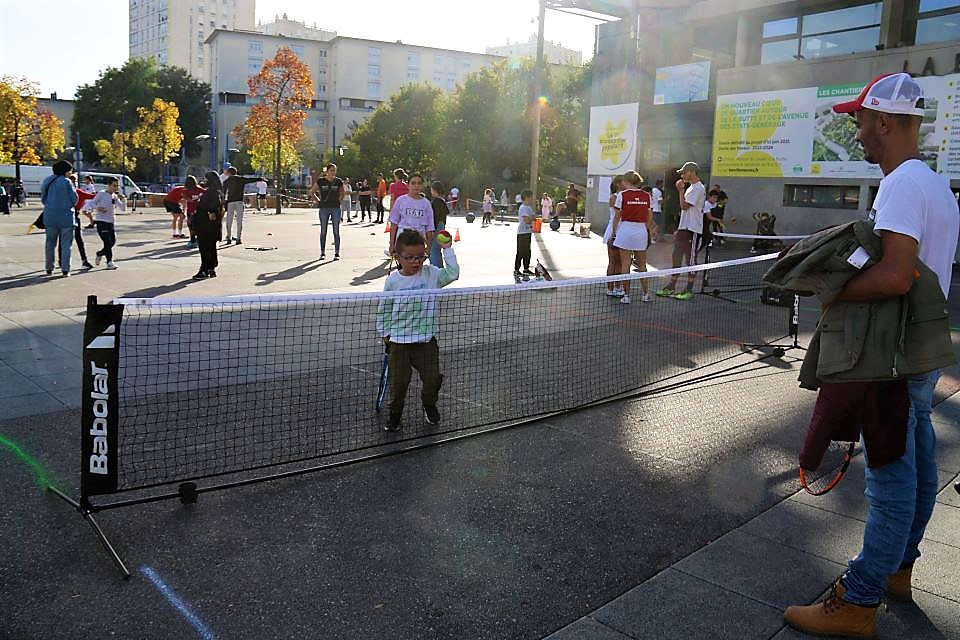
[587,102,640,176]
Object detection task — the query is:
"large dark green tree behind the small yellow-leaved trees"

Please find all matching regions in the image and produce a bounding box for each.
[73,58,211,178]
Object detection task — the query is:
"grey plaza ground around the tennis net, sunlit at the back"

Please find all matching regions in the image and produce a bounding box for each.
[0,206,960,640]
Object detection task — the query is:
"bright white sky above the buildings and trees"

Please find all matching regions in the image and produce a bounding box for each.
[0,0,598,99]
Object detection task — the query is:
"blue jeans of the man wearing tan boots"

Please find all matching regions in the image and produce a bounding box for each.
[843,371,940,605]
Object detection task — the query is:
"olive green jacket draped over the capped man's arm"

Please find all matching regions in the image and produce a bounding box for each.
[763,220,956,389]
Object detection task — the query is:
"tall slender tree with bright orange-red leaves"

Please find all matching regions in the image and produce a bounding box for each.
[235,47,313,213]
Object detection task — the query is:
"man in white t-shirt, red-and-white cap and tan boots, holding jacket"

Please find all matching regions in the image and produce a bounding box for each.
[784,73,960,637]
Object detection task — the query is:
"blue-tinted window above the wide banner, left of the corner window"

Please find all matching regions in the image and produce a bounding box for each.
[760,2,883,64]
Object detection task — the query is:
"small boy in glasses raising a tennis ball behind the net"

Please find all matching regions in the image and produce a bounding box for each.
[377,229,460,431]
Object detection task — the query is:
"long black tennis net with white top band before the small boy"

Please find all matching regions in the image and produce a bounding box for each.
[81,254,791,508]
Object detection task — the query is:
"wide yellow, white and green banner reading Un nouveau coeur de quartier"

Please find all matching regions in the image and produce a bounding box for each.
[713,74,960,179]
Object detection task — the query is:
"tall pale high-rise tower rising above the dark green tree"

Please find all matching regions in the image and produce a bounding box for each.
[129,0,256,82]
